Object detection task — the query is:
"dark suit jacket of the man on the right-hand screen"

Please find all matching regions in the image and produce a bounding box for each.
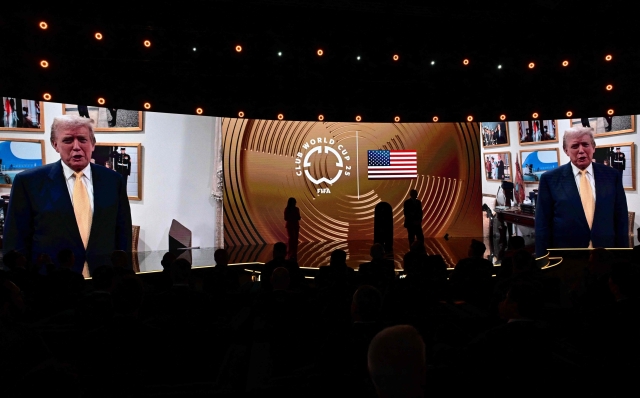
[536,163,629,256]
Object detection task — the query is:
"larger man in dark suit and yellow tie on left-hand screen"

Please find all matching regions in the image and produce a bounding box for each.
[3,115,131,277]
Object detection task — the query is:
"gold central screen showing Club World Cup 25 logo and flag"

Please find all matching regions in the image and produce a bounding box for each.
[222,118,482,246]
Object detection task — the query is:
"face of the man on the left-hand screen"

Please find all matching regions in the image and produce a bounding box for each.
[53,127,95,172]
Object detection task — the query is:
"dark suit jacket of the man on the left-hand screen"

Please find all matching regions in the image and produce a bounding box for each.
[4,161,131,272]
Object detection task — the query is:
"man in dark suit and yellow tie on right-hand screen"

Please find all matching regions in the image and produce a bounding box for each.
[536,127,629,256]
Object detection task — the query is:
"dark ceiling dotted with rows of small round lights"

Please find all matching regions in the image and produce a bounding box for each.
[0,0,640,122]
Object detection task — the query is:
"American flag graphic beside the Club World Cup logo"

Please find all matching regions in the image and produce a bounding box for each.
[367,149,418,180]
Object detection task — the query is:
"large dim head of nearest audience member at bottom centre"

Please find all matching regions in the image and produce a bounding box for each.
[368,325,427,397]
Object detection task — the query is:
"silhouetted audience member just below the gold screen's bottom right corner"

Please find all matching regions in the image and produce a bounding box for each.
[449,239,493,304]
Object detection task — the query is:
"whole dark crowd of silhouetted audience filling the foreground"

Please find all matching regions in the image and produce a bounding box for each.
[0,237,640,397]
